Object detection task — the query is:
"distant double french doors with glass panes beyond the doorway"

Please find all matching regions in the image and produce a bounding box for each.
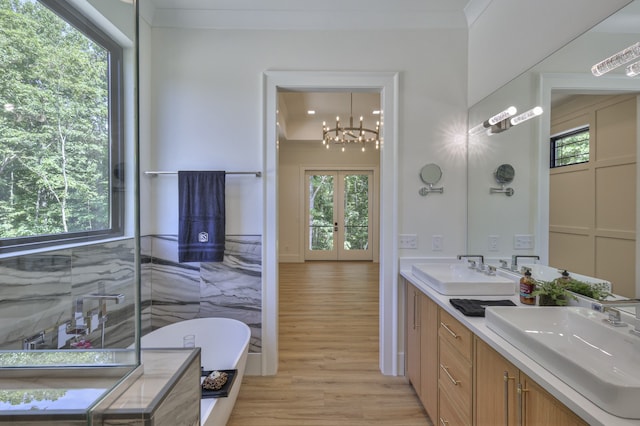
[305,170,373,260]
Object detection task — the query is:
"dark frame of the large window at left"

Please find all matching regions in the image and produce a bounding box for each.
[0,0,125,254]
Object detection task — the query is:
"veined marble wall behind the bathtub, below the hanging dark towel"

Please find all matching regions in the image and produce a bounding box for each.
[141,235,262,352]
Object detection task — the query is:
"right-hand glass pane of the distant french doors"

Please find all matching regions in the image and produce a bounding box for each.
[344,174,369,250]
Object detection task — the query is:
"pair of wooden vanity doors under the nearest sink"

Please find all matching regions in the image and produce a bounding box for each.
[474,337,587,426]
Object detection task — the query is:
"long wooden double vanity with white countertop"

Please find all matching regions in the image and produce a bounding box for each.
[400,265,640,426]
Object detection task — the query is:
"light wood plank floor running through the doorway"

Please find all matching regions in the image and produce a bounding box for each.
[228,262,431,426]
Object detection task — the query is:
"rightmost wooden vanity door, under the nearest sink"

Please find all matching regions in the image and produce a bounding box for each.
[520,373,587,426]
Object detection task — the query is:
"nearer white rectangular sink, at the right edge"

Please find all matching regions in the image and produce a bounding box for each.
[485,307,640,419]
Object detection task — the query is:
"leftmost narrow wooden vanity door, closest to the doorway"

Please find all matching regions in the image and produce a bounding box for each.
[405,284,422,396]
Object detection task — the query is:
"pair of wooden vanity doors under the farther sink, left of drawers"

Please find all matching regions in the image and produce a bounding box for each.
[405,284,438,419]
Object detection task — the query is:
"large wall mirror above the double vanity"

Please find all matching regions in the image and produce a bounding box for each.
[467,0,640,297]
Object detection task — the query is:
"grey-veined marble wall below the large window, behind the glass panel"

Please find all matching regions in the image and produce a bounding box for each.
[0,239,136,350]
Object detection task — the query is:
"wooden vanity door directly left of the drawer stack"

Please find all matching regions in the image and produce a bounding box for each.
[420,294,438,419]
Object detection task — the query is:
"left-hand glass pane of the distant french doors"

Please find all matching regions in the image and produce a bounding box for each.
[309,175,334,250]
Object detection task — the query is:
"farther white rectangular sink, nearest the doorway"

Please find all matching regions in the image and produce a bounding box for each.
[411,263,516,296]
